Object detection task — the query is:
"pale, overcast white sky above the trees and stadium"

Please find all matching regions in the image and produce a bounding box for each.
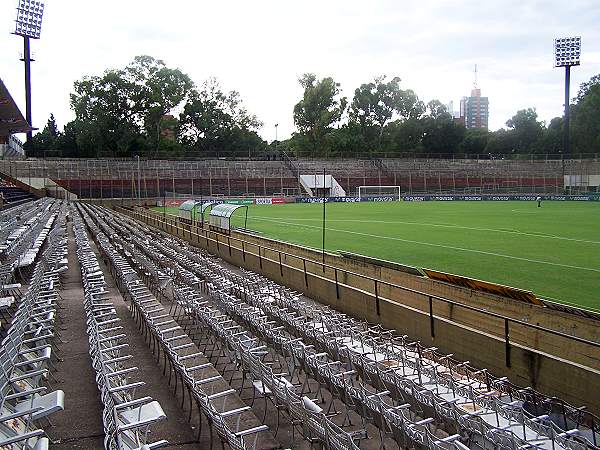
[0,0,600,141]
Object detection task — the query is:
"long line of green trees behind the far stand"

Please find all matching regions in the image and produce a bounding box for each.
[26,56,600,158]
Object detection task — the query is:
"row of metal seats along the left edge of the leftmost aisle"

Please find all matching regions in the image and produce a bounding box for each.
[0,203,67,450]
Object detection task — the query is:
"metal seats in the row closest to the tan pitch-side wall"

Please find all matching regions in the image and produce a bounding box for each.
[84,206,597,449]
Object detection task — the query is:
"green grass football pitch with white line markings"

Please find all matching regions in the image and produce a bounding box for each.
[159,201,600,310]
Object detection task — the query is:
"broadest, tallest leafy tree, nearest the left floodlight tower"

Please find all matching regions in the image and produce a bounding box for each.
[71,56,193,156]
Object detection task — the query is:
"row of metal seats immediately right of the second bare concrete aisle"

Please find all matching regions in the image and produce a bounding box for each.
[80,204,276,449]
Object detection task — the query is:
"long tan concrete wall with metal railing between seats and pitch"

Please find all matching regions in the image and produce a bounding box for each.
[118,208,600,413]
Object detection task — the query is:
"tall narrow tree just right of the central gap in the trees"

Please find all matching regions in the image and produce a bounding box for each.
[294,73,347,154]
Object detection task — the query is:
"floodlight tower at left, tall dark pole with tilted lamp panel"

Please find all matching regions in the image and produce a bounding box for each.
[13,0,44,142]
